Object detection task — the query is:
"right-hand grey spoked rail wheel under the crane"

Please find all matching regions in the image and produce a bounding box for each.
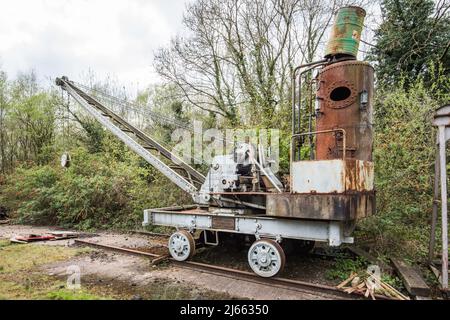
[248,239,286,278]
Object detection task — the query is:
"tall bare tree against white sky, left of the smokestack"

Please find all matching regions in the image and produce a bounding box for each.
[155,0,367,128]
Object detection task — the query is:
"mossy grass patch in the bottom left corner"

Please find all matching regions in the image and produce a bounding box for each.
[0,241,237,300]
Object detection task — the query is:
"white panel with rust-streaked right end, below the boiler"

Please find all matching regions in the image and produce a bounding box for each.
[291,159,374,194]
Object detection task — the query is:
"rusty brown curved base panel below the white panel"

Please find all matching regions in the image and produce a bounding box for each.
[266,192,375,221]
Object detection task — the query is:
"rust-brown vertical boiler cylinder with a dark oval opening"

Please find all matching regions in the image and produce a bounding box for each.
[316,60,374,161]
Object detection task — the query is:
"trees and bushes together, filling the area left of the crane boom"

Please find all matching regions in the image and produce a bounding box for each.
[0,73,187,229]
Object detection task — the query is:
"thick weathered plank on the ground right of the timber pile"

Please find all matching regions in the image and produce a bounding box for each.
[391,258,430,297]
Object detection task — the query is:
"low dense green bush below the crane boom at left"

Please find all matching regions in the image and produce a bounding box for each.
[0,148,188,229]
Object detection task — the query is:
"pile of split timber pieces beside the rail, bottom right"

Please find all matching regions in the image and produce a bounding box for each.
[337,272,410,300]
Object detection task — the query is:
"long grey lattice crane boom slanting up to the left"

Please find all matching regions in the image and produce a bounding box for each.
[56,77,205,202]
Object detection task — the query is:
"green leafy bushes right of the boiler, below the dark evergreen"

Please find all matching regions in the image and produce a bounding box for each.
[357,71,450,259]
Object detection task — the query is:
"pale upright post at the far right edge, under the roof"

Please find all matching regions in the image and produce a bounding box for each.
[439,126,448,291]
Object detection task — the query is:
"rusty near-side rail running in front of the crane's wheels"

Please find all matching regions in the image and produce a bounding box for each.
[75,239,389,300]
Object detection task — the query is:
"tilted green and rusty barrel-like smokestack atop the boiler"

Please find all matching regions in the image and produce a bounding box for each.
[325,6,366,58]
